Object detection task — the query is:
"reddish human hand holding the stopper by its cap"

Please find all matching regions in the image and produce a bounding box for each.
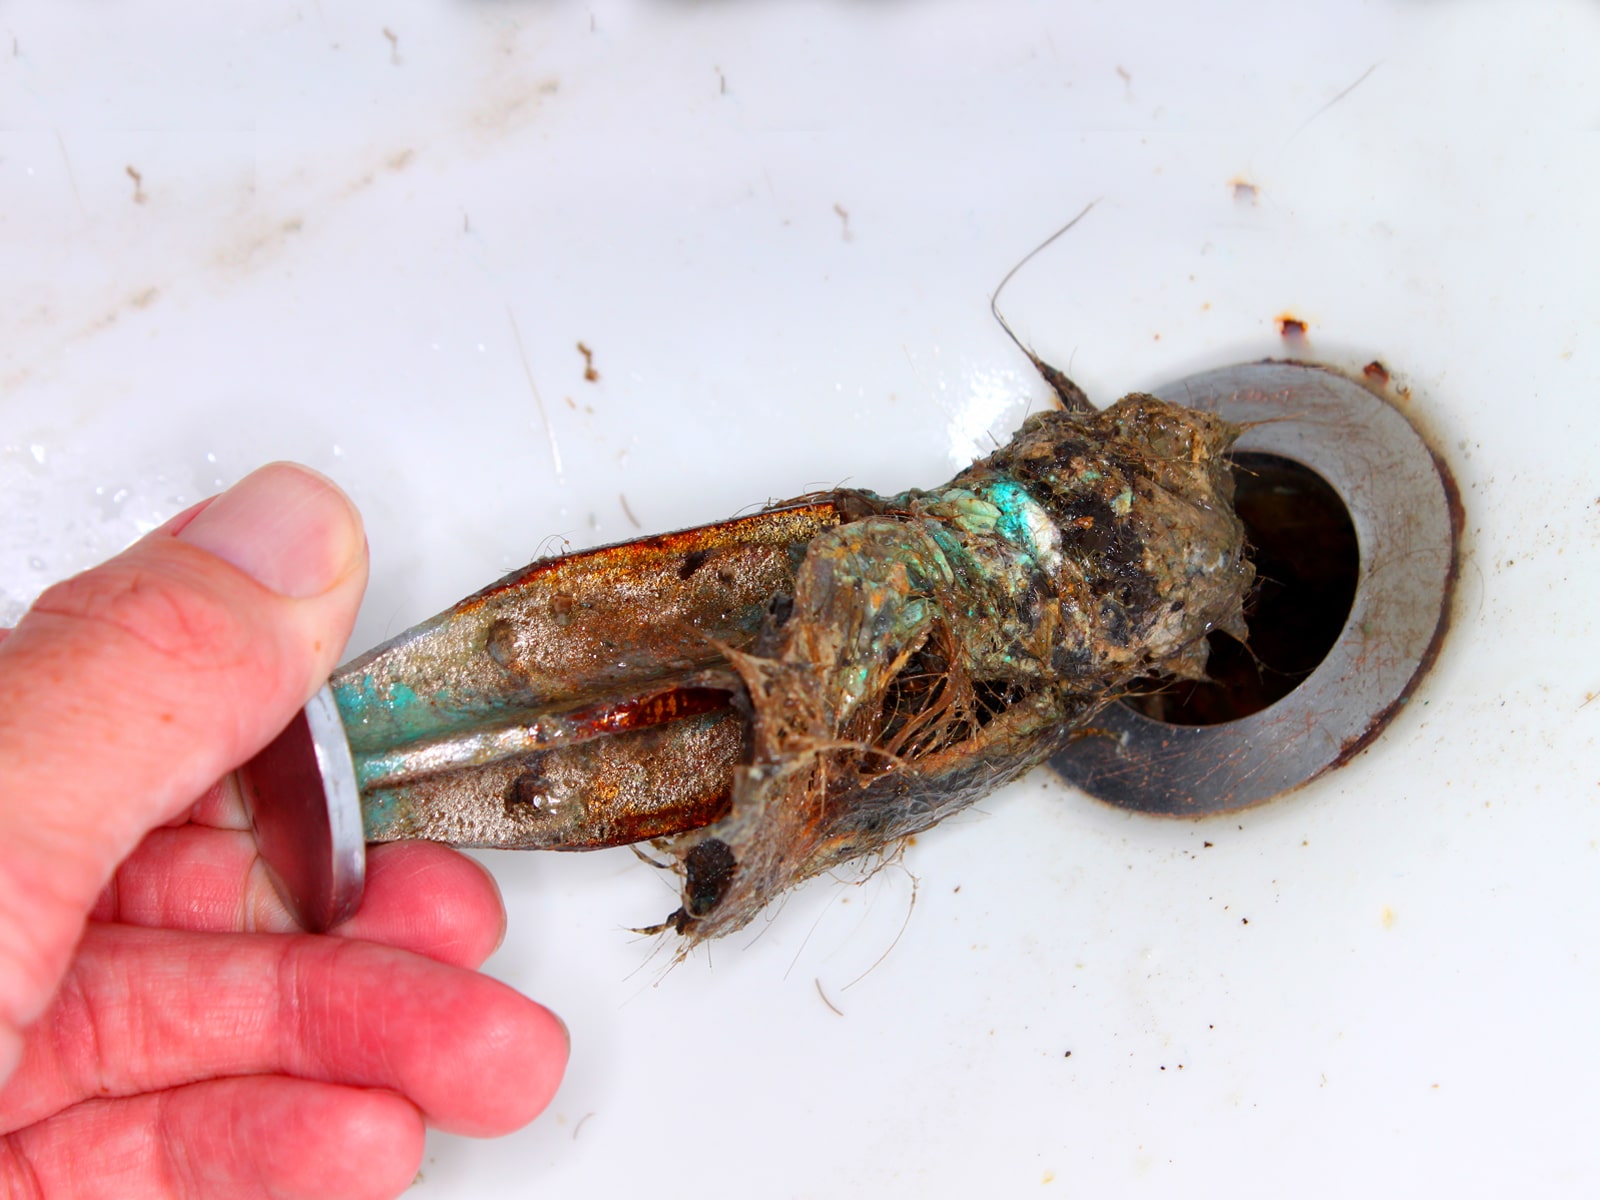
[0,464,566,1197]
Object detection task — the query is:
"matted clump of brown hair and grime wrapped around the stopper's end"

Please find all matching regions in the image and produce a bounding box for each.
[666,397,1253,942]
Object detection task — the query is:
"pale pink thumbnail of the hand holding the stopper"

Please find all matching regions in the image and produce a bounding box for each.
[178,462,365,600]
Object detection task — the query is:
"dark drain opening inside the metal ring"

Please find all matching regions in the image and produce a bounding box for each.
[1123,451,1360,725]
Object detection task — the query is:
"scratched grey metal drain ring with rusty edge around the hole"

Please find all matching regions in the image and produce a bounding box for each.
[1051,362,1461,816]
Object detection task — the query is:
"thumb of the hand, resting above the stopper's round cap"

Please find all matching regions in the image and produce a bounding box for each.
[0,462,366,1078]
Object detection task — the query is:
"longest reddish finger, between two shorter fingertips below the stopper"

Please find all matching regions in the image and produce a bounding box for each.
[0,925,566,1136]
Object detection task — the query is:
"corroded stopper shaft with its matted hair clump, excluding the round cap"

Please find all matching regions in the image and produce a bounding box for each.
[318,385,1251,944]
